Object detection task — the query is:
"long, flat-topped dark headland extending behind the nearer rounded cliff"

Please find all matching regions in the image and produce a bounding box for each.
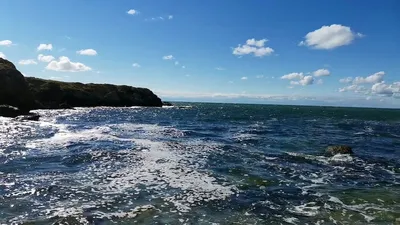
[26,77,162,109]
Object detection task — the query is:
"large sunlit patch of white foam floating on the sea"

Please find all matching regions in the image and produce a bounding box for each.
[4,113,237,222]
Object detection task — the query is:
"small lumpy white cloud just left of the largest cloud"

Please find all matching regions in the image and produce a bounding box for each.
[233,38,274,57]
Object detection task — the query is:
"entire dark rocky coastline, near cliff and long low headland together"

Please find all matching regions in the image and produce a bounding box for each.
[0,58,163,114]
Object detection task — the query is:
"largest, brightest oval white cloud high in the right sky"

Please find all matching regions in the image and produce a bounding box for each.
[299,24,363,49]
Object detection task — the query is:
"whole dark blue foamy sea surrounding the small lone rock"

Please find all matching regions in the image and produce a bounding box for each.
[0,103,400,225]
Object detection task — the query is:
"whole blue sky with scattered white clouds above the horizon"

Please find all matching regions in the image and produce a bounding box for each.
[0,0,400,108]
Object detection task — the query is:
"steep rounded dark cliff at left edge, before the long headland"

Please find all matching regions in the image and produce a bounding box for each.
[0,58,34,113]
